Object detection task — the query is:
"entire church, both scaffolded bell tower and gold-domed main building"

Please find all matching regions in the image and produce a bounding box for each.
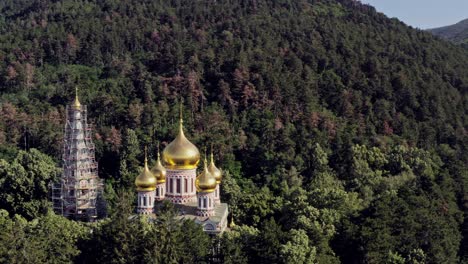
[50,92,229,235]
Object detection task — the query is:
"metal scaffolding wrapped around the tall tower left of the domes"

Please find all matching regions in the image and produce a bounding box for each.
[51,103,103,221]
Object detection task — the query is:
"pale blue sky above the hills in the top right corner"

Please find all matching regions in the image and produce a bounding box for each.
[361,0,468,29]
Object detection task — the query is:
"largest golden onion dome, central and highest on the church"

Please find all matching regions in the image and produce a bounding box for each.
[163,118,200,170]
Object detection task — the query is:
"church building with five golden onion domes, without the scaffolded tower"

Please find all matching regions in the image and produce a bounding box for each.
[135,106,228,235]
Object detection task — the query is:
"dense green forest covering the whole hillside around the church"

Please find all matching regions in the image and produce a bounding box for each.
[0,0,468,264]
